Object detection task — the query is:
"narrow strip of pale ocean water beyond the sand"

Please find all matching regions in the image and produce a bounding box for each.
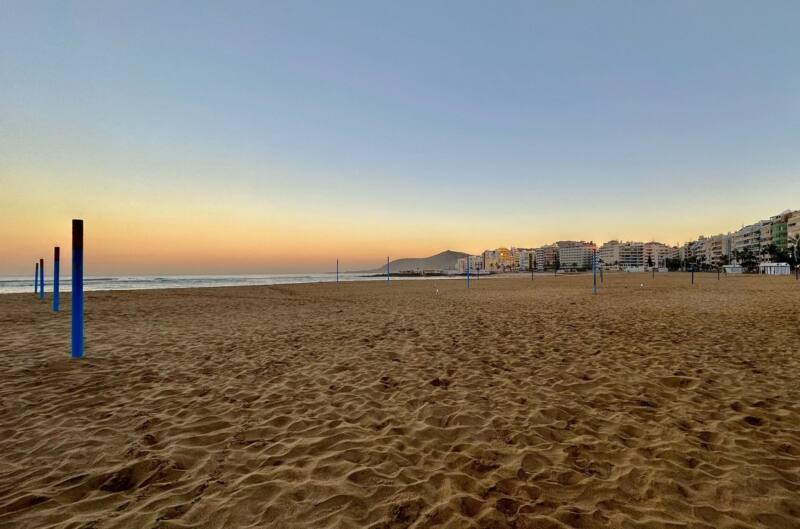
[0,273,456,294]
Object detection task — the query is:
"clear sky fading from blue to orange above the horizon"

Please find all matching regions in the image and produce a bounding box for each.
[0,0,800,275]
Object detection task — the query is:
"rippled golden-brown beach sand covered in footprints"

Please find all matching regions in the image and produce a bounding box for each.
[0,274,800,529]
